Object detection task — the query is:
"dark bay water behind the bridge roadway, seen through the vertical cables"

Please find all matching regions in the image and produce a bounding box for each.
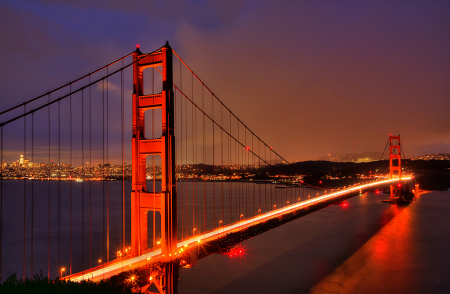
[2,180,316,278]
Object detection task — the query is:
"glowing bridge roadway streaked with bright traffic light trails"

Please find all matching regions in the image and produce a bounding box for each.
[64,177,412,281]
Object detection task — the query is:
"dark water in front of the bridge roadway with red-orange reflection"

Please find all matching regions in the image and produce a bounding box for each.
[179,191,450,294]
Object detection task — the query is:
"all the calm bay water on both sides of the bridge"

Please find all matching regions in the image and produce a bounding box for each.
[2,181,450,294]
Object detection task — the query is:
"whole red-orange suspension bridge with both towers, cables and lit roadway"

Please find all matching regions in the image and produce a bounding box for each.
[0,43,412,293]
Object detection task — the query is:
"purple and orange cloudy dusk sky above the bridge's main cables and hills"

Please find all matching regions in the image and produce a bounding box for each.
[0,0,450,161]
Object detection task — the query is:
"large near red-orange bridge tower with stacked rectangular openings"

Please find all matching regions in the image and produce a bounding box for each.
[131,43,178,293]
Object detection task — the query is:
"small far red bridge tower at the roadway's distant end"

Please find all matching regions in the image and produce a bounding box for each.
[389,135,403,202]
